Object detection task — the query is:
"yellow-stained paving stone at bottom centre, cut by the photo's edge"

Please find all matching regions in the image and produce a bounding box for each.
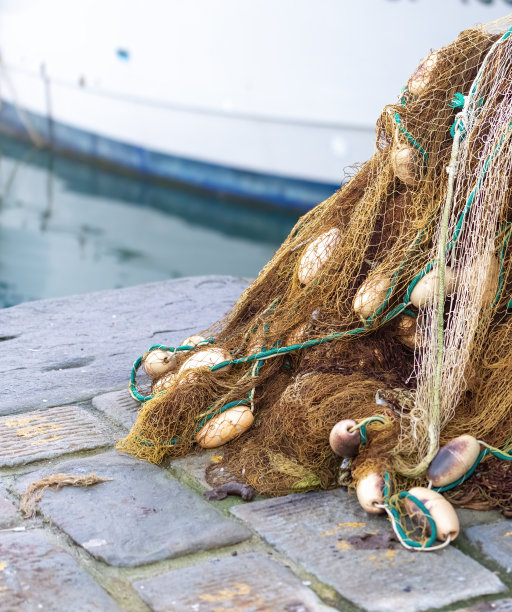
[134,553,333,612]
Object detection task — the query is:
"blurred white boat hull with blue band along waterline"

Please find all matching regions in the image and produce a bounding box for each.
[0,0,511,210]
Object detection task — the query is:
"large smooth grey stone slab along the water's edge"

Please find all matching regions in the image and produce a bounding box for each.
[0,276,248,414]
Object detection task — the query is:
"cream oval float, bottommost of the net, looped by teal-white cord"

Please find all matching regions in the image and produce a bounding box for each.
[405,487,459,542]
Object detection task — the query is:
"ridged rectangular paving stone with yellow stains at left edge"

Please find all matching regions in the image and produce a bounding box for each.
[0,406,116,466]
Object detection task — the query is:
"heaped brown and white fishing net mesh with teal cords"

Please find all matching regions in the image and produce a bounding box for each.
[118,18,512,513]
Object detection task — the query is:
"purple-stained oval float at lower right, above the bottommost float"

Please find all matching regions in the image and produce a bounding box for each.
[427,434,481,487]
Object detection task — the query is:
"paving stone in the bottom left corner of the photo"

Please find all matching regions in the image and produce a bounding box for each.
[0,531,121,612]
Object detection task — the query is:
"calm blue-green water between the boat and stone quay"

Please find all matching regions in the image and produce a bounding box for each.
[0,136,298,307]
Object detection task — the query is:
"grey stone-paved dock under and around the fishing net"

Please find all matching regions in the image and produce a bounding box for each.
[0,276,512,612]
